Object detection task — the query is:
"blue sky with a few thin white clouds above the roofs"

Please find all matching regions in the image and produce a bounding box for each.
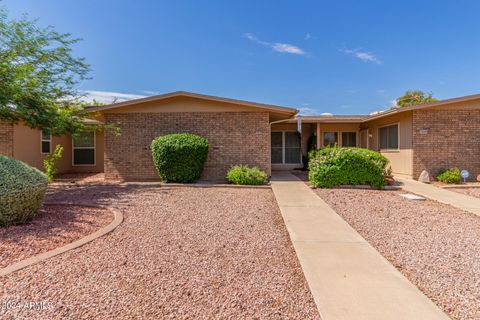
[0,0,480,114]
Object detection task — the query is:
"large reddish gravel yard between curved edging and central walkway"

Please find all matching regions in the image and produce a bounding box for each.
[0,186,319,319]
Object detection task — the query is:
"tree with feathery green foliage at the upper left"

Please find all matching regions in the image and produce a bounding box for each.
[0,8,97,135]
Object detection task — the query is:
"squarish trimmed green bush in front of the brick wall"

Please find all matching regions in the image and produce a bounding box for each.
[151,133,208,182]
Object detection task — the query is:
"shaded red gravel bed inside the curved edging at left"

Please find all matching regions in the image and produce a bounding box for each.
[0,205,113,268]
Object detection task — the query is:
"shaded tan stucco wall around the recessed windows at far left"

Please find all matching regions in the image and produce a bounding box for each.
[13,124,104,173]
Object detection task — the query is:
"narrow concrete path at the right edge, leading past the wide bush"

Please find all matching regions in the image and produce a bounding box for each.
[395,177,480,216]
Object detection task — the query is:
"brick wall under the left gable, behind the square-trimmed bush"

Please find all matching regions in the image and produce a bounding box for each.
[105,112,270,181]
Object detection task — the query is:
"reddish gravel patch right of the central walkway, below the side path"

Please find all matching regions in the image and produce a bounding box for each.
[315,189,480,320]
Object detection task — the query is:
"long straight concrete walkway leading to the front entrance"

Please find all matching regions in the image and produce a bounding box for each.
[272,172,449,320]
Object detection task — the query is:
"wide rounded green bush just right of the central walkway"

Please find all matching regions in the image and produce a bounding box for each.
[308,147,388,188]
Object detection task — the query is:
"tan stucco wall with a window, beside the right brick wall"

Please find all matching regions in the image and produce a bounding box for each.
[361,111,413,176]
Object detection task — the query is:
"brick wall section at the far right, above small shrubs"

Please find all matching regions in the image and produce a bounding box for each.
[413,110,480,180]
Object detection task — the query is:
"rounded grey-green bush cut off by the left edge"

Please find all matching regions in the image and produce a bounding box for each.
[0,155,48,226]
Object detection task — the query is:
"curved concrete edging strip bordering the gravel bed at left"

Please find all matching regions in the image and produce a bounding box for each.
[0,202,123,277]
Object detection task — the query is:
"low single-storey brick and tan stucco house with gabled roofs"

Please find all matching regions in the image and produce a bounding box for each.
[0,92,480,180]
